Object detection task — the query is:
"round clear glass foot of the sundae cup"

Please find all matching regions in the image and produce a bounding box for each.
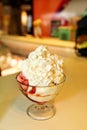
[27,104,56,120]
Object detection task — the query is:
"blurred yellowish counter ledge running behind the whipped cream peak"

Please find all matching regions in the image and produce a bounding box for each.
[1,35,75,56]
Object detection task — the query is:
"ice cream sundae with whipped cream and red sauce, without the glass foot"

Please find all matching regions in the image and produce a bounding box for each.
[17,45,64,103]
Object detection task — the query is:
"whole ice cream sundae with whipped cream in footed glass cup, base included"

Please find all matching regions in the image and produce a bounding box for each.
[16,45,66,120]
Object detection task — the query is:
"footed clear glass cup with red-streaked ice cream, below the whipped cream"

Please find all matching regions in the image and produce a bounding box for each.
[16,73,66,120]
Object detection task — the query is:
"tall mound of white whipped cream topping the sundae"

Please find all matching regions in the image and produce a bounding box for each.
[21,45,63,86]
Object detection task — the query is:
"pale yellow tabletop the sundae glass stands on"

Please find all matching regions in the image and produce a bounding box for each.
[0,48,87,130]
